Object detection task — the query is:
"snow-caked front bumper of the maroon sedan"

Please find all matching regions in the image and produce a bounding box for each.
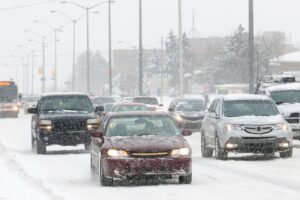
[102,157,192,180]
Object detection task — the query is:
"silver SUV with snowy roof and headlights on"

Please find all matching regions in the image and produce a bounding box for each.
[201,94,293,160]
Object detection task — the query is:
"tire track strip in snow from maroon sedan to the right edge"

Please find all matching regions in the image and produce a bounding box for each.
[193,158,300,192]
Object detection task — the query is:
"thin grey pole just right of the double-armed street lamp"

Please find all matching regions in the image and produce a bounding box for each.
[108,0,113,96]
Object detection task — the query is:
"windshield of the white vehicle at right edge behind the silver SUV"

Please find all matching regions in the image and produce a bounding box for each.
[271,90,300,104]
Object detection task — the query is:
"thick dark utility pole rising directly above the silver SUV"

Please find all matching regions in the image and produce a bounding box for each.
[249,0,254,94]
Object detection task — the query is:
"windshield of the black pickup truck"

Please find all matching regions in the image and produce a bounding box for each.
[40,95,93,113]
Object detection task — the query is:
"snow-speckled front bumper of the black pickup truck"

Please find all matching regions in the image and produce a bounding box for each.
[40,131,91,146]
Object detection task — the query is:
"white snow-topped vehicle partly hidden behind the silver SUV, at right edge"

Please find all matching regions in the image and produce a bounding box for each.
[266,83,300,140]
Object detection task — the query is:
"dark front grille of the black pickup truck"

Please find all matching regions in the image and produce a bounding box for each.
[53,119,86,132]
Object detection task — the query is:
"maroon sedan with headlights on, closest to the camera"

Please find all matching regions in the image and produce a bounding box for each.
[91,112,192,186]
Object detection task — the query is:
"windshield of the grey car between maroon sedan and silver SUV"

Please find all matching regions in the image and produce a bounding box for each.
[176,100,205,112]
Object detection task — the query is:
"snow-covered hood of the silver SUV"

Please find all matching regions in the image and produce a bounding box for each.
[225,115,284,125]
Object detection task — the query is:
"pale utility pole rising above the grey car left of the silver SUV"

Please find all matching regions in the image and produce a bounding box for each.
[178,0,184,97]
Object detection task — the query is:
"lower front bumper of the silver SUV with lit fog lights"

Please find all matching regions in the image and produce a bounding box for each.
[224,138,292,153]
